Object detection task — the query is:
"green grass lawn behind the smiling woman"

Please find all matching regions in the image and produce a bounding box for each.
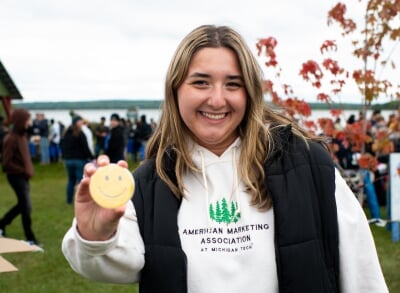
[0,162,400,293]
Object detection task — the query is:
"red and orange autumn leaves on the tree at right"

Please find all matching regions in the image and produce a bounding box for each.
[256,0,400,170]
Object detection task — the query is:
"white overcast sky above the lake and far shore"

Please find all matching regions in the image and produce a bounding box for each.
[0,0,384,101]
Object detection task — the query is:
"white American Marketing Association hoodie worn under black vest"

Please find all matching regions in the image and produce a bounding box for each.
[62,139,388,293]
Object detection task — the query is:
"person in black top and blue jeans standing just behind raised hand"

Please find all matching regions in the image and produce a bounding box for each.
[61,116,93,204]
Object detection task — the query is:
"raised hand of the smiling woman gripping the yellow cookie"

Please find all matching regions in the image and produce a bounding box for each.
[75,155,128,241]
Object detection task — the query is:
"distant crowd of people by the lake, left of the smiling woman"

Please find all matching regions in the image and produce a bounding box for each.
[10,113,157,165]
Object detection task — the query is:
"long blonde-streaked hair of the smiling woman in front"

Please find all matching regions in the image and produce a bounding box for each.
[146,25,307,209]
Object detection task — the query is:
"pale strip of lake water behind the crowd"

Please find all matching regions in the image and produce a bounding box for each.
[31,105,394,126]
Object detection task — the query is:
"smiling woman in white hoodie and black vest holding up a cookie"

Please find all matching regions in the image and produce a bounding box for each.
[63,26,387,293]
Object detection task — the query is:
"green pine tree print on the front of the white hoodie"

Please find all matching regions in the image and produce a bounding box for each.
[208,198,240,224]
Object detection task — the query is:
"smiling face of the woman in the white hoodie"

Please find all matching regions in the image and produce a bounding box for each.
[178,48,247,155]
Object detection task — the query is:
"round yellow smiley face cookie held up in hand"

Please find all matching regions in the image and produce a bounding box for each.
[89,164,135,209]
